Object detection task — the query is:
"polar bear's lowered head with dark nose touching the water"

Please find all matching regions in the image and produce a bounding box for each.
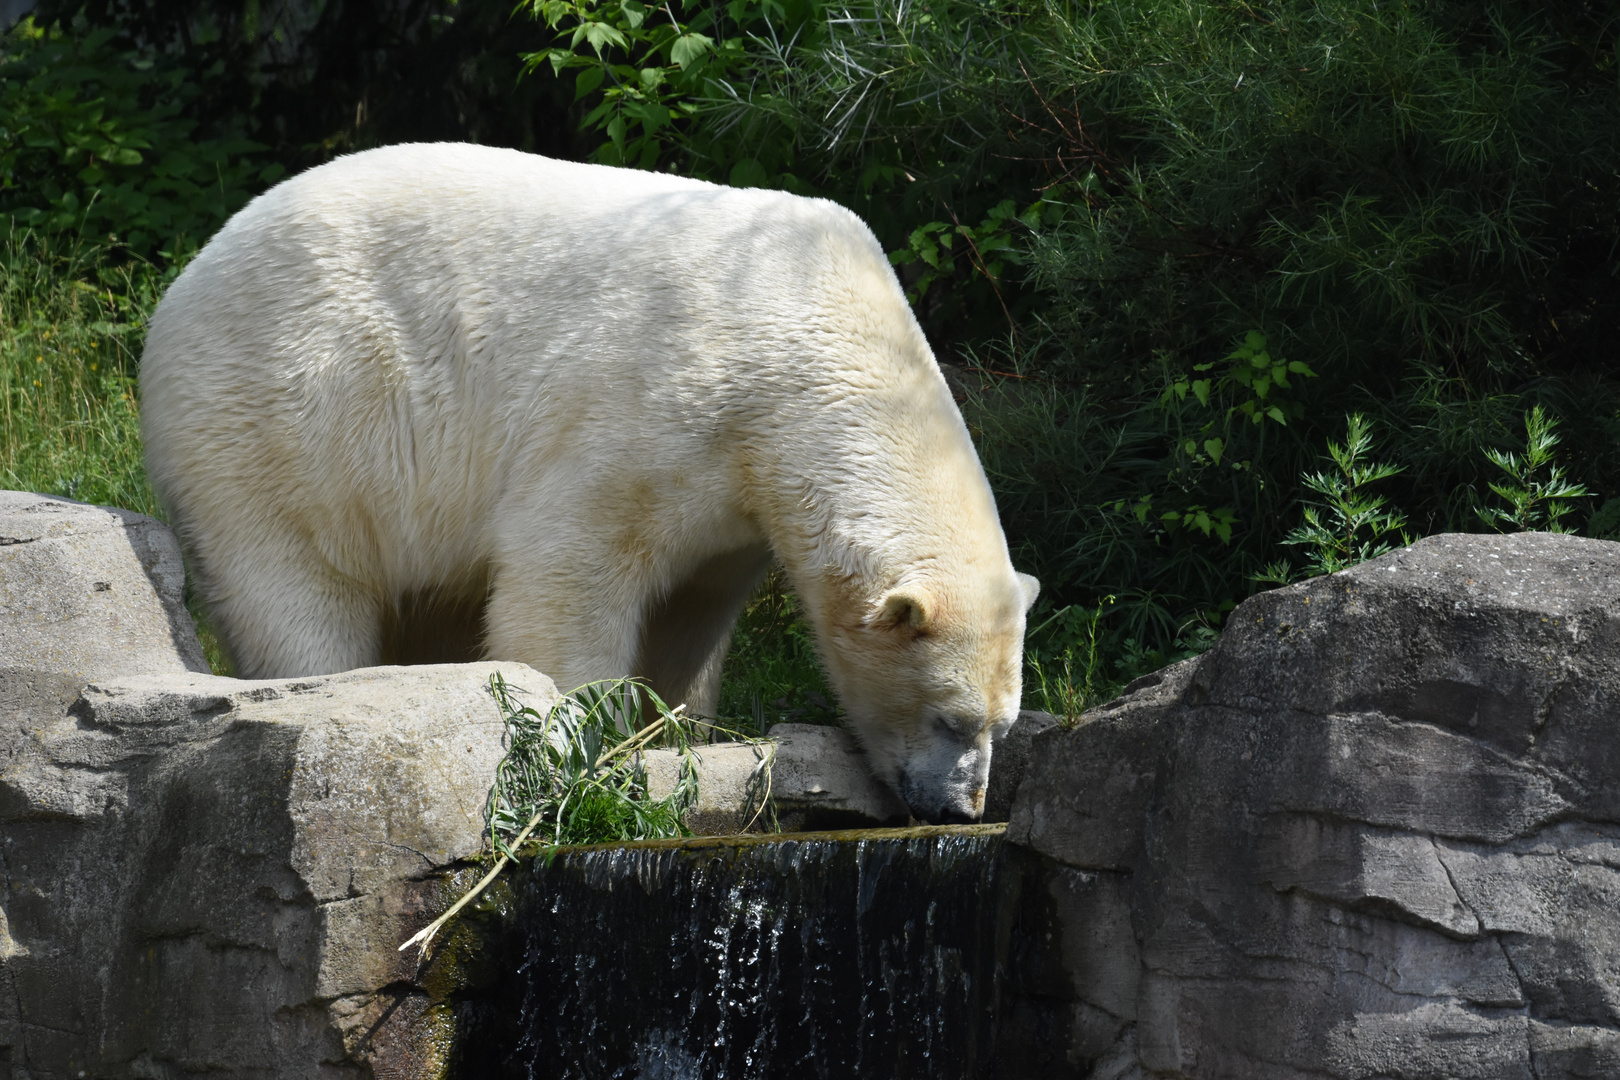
[810,562,1040,823]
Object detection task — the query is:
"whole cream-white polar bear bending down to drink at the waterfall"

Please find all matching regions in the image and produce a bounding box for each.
[141,144,1037,821]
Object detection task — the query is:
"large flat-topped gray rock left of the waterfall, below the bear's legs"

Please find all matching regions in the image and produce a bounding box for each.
[0,664,556,1080]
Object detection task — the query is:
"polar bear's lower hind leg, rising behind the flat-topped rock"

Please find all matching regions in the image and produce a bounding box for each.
[193,536,382,678]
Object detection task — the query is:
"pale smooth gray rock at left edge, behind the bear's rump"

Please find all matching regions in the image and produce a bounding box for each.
[0,491,207,680]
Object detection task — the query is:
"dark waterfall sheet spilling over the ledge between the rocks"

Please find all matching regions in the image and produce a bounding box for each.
[455,826,1016,1080]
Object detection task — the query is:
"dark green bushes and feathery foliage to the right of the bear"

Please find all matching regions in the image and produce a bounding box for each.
[541,0,1620,705]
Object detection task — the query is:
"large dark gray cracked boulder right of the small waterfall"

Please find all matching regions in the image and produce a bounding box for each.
[1006,534,1620,1080]
